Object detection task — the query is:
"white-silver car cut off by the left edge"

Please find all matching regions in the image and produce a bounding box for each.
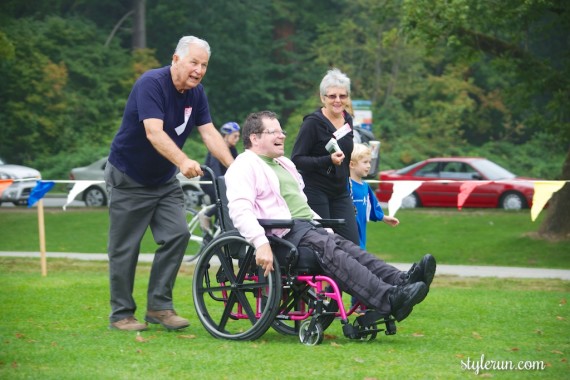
[0,160,42,206]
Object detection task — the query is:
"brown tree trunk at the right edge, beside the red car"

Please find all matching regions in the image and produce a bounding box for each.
[538,148,570,240]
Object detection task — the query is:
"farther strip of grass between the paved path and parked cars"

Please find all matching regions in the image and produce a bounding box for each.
[0,208,570,268]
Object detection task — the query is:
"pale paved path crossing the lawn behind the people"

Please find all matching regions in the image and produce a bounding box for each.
[0,252,570,280]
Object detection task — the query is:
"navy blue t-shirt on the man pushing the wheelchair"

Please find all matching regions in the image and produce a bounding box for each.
[109,66,212,186]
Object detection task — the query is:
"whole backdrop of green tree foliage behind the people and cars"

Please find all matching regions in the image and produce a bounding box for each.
[0,0,570,197]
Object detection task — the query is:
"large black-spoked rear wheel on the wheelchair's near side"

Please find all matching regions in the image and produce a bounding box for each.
[192,231,281,340]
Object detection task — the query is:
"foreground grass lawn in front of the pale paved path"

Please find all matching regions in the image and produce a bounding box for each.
[0,258,570,379]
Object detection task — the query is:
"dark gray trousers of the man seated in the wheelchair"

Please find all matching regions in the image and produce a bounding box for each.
[292,227,407,314]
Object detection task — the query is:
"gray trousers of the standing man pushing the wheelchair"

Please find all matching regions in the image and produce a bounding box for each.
[105,163,190,322]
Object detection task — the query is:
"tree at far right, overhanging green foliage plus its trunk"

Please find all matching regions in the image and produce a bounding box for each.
[403,0,570,238]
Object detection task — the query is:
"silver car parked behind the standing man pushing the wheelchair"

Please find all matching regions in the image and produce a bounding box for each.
[69,157,204,210]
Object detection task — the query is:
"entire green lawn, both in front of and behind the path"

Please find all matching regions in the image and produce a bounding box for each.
[0,209,570,379]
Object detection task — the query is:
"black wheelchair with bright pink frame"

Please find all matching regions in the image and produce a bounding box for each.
[192,167,396,346]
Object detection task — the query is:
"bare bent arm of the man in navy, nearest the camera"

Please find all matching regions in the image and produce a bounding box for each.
[143,119,203,178]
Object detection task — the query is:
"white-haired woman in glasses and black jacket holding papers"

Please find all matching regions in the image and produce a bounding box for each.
[291,68,359,244]
